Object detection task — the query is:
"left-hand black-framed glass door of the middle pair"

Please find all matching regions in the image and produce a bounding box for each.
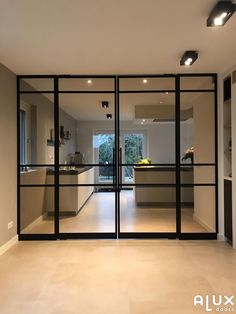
[59,76,116,238]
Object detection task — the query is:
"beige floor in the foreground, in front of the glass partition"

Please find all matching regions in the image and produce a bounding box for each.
[0,240,236,314]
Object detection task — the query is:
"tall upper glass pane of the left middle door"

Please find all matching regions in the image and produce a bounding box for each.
[59,93,115,164]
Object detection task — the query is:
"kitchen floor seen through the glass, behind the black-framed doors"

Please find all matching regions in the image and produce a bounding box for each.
[21,191,207,233]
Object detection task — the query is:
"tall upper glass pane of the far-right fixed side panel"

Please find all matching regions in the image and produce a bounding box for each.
[180,92,215,164]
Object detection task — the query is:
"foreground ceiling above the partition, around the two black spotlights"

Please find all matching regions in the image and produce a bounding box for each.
[0,0,236,74]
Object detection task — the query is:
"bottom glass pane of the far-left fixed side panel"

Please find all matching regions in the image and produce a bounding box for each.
[20,187,54,234]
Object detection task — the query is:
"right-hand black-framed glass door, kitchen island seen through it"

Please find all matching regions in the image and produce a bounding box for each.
[119,76,177,238]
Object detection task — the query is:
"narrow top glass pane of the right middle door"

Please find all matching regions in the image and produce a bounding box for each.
[119,77,175,91]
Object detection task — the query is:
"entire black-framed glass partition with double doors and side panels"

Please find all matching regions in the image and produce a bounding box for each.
[17,73,218,240]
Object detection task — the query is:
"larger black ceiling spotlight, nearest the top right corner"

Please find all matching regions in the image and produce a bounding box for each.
[207,1,236,26]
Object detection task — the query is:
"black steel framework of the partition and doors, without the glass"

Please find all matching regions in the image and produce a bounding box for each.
[17,73,218,240]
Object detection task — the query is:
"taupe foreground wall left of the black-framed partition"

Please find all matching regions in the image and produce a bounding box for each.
[0,64,17,246]
